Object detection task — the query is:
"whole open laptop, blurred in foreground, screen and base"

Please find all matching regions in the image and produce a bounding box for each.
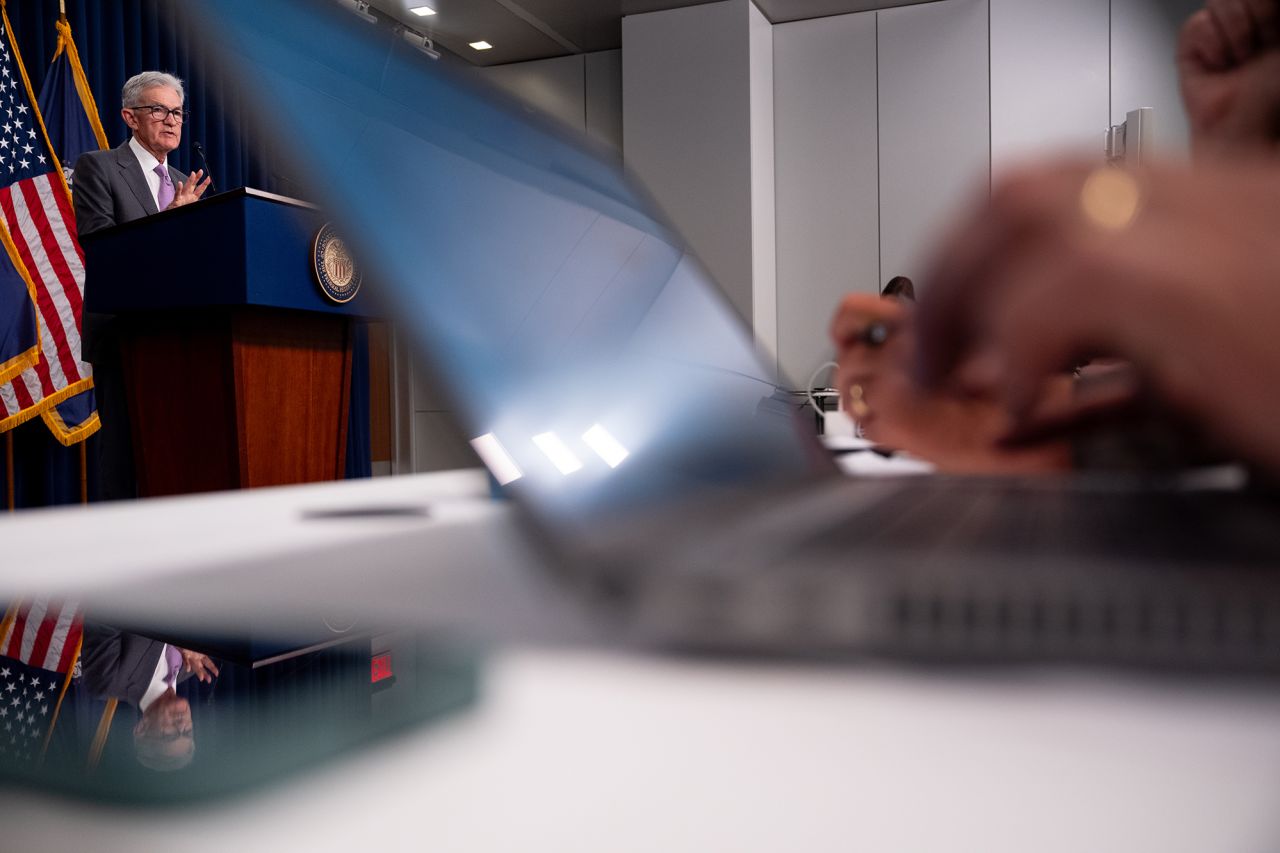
[175,0,1280,670]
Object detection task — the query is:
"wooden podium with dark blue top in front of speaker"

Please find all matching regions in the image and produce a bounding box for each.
[83,190,365,497]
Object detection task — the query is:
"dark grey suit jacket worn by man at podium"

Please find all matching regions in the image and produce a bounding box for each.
[72,140,187,237]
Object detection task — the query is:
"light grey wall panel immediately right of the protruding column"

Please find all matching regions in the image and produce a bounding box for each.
[773,12,879,387]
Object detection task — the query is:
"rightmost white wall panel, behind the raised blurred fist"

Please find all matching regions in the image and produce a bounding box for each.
[1111,0,1203,159]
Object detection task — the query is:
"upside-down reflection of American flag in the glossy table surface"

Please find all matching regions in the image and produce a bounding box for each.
[0,598,84,765]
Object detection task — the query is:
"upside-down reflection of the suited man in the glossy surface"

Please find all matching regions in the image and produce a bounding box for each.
[81,622,218,771]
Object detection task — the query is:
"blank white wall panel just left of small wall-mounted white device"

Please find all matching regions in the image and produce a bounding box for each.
[991,0,1110,175]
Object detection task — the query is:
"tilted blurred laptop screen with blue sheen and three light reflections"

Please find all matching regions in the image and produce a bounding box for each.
[188,0,829,524]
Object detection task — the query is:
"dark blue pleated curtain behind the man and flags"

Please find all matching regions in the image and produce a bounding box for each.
[0,0,371,508]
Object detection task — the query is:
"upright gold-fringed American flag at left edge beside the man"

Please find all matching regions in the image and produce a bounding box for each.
[0,6,93,432]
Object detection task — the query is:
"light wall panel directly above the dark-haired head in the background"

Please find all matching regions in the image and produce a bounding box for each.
[878,0,991,288]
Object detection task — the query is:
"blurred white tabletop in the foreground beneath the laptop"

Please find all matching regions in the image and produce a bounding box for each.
[0,473,1280,852]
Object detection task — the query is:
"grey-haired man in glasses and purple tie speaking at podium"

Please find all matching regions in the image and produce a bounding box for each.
[72,72,209,237]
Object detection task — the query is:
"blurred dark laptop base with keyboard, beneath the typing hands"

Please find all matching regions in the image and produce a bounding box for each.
[622,478,1280,674]
